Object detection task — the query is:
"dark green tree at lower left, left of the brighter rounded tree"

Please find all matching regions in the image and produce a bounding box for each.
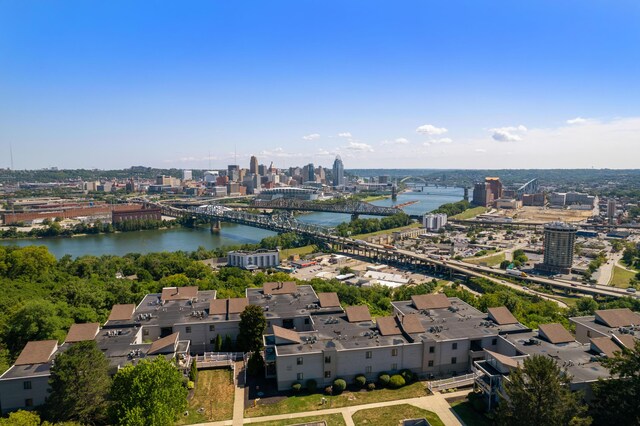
[46,340,111,424]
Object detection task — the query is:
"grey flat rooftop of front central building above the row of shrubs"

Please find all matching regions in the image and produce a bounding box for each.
[276,313,410,355]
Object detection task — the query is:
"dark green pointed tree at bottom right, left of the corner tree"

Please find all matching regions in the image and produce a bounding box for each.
[496,355,589,426]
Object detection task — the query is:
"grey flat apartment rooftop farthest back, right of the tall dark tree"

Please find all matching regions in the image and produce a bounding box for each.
[246,285,342,321]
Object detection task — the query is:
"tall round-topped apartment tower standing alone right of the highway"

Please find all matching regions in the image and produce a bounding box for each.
[539,222,578,274]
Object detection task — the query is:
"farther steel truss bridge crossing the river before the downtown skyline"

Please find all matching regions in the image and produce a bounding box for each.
[250,198,402,219]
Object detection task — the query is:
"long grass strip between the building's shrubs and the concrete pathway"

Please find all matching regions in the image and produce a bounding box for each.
[245,382,427,417]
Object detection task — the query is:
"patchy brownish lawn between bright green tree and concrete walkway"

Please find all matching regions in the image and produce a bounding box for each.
[178,369,235,424]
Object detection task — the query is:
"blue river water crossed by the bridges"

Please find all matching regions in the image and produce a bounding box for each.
[0,187,463,258]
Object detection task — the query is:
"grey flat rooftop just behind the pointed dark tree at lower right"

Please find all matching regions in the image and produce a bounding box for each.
[502,331,609,383]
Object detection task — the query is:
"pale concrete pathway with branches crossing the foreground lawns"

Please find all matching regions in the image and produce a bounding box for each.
[192,386,462,426]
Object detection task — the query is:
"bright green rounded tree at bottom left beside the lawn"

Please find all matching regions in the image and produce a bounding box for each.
[111,357,187,426]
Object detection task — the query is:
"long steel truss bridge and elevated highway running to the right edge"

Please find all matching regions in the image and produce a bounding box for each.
[154,204,628,297]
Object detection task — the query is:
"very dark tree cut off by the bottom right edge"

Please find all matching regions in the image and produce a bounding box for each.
[591,340,640,425]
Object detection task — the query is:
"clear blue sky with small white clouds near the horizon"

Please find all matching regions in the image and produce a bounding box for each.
[0,0,640,169]
